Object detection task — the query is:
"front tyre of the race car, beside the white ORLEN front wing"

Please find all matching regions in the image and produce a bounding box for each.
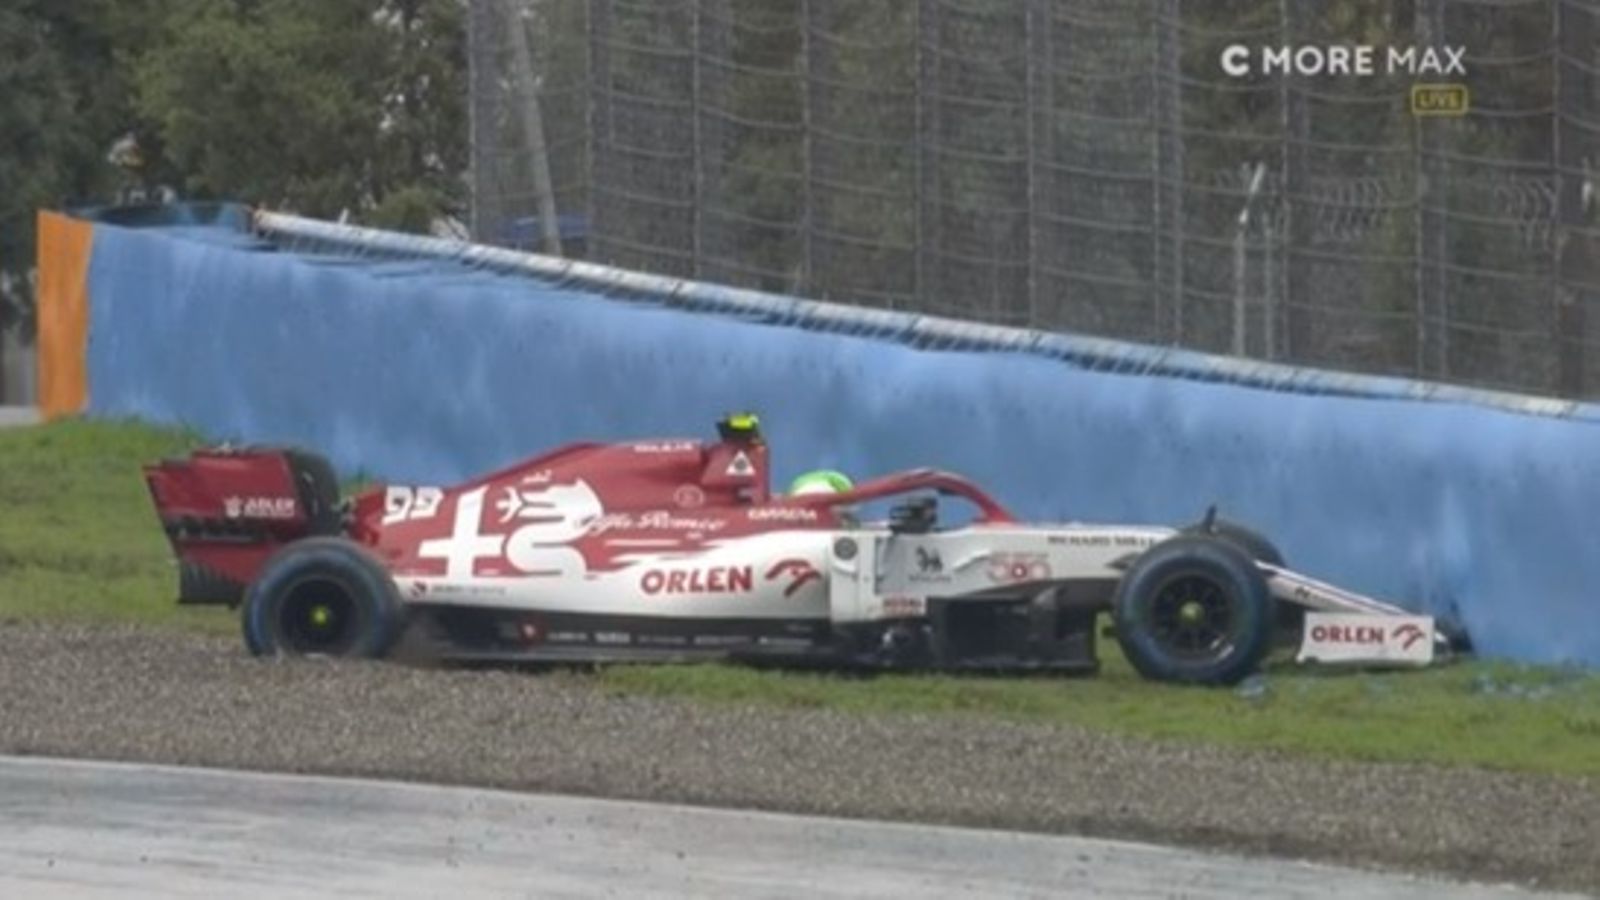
[1112,535,1275,685]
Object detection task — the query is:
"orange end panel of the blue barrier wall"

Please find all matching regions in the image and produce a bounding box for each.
[38,210,94,418]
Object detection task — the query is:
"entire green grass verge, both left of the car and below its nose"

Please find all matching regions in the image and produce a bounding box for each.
[0,421,1600,777]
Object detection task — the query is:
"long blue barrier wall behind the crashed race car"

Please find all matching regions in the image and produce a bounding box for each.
[88,224,1600,665]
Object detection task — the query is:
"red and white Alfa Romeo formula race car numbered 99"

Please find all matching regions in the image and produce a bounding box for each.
[146,415,1435,684]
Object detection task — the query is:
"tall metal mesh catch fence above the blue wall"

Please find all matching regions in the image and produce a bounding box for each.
[470,0,1600,397]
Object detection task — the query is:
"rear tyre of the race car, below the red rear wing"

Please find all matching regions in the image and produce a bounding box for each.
[242,536,405,658]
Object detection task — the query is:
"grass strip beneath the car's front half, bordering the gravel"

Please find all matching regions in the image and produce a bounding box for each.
[602,641,1600,777]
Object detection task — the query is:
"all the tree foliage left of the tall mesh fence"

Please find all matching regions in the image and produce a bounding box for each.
[0,0,467,327]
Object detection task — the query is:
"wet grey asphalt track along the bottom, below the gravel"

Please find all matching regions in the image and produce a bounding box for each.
[0,756,1574,900]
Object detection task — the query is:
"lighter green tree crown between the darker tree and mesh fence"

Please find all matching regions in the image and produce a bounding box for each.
[134,0,466,224]
